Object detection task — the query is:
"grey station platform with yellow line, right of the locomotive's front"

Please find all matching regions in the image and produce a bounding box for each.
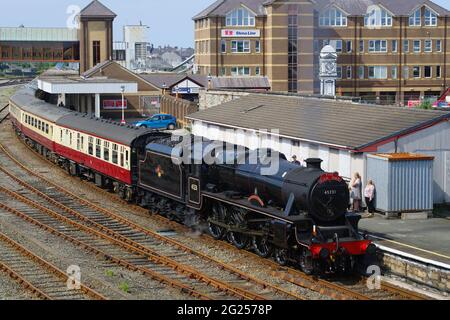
[360,215,450,270]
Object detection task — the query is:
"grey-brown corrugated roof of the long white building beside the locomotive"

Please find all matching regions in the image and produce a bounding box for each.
[187,94,450,150]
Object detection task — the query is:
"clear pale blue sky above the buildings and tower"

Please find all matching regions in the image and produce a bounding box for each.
[0,0,450,47]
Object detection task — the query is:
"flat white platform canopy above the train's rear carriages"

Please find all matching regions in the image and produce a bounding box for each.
[38,77,138,94]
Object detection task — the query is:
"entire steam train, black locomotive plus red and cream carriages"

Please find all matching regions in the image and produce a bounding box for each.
[10,88,376,273]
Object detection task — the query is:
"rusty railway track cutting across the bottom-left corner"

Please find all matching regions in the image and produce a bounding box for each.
[0,233,106,300]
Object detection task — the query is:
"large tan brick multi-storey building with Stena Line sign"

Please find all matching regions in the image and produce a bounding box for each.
[193,0,450,103]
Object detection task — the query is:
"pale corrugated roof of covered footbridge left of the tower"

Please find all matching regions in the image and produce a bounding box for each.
[0,28,79,42]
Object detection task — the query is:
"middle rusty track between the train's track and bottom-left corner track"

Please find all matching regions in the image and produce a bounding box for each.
[0,145,302,300]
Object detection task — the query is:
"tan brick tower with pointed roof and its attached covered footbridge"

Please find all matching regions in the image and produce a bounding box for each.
[0,0,116,73]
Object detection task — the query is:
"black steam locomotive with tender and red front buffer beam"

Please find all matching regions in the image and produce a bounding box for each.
[136,135,375,274]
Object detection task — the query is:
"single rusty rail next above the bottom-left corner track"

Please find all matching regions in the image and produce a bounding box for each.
[0,202,211,300]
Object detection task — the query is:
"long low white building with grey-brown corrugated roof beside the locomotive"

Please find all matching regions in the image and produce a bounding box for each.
[187,94,450,204]
